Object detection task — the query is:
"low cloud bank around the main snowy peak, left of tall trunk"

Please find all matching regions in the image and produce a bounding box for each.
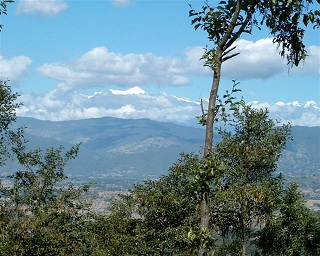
[18,88,200,125]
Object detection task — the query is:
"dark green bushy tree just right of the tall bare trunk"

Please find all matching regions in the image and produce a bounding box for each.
[211,106,290,256]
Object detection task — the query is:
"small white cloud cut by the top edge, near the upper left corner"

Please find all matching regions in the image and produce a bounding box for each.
[17,0,68,16]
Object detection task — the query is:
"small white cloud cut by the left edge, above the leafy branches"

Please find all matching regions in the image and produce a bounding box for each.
[0,55,32,85]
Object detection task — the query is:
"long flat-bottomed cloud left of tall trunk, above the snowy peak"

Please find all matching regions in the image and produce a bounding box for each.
[38,47,189,91]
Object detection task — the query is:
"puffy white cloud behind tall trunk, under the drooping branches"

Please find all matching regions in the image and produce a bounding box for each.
[182,38,320,80]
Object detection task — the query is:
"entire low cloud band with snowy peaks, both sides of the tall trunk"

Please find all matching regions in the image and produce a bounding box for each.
[18,87,320,127]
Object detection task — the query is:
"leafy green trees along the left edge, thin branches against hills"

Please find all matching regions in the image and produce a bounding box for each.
[0,79,95,255]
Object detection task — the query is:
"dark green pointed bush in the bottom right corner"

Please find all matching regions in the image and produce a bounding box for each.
[256,183,320,256]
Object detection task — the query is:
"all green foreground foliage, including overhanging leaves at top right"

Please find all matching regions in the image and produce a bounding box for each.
[0,1,320,256]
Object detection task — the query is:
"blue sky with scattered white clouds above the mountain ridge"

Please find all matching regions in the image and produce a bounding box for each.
[0,0,320,126]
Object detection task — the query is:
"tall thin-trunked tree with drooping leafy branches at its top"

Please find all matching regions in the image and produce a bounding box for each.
[189,0,320,255]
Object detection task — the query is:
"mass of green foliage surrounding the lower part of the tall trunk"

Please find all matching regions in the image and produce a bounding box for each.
[103,105,319,255]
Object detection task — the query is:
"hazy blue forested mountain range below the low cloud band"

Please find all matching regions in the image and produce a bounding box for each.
[2,117,320,189]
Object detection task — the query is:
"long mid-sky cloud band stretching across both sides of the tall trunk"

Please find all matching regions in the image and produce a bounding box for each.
[38,38,320,91]
